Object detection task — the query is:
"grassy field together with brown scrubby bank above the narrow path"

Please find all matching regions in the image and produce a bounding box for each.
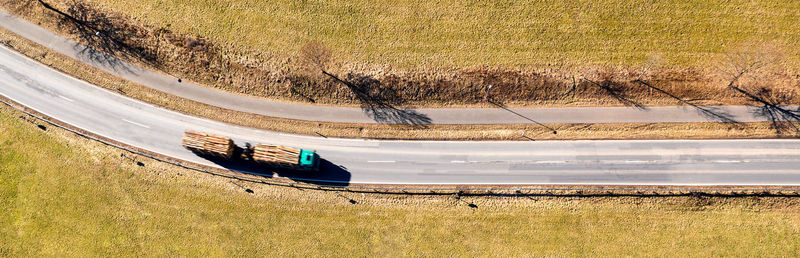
[5,0,800,106]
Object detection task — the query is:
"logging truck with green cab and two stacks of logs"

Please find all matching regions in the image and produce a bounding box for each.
[181,130,320,172]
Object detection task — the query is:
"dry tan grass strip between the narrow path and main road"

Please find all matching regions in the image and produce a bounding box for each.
[0,24,792,140]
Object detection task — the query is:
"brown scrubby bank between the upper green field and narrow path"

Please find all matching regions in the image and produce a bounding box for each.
[6,0,798,106]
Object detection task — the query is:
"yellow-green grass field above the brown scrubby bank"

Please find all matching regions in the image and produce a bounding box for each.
[84,0,800,67]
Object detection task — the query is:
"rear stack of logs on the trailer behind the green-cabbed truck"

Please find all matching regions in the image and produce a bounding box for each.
[181,130,234,159]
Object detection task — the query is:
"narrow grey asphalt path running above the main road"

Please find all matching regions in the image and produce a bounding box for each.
[0,10,780,124]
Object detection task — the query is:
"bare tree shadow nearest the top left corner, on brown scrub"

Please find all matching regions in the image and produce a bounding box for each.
[38,0,157,72]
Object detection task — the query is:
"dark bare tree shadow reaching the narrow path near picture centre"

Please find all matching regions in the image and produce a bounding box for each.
[322,71,431,128]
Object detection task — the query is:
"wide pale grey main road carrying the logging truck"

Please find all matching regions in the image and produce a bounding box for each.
[0,44,800,185]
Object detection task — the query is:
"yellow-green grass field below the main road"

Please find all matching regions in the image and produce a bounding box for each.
[0,108,800,257]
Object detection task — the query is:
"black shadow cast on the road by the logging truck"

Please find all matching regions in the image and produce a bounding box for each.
[194,149,350,187]
